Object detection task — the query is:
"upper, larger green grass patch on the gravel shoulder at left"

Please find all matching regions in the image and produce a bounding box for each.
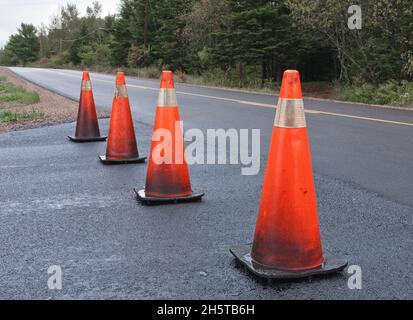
[0,76,40,105]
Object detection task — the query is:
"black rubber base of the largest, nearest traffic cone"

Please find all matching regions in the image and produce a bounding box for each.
[230,244,348,279]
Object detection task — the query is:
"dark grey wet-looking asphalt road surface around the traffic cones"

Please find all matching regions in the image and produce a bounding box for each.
[0,68,413,299]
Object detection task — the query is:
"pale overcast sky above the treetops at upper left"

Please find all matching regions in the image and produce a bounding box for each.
[0,0,120,48]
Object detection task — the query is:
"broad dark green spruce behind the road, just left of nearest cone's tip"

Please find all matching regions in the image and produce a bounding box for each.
[210,0,305,83]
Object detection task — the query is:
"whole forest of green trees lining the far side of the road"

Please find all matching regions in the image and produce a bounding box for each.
[0,0,413,102]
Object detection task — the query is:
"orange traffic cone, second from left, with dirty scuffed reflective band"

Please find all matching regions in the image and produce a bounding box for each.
[99,72,146,164]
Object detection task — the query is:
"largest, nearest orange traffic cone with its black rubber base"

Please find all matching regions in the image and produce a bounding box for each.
[231,70,347,278]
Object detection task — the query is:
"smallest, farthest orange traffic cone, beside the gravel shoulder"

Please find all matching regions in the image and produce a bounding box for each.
[69,71,106,142]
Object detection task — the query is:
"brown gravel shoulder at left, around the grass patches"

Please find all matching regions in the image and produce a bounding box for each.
[0,68,107,132]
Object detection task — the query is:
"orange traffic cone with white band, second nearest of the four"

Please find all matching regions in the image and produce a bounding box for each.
[135,71,204,204]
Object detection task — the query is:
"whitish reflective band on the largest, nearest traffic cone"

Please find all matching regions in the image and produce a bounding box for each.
[274,98,307,129]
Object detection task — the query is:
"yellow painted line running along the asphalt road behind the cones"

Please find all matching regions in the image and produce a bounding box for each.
[37,71,413,127]
